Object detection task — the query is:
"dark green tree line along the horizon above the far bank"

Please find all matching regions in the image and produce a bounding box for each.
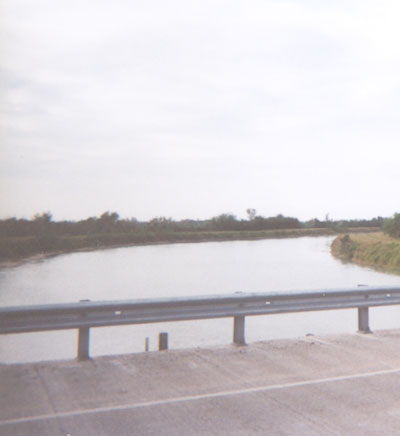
[0,209,384,238]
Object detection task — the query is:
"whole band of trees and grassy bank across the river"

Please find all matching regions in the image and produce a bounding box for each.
[0,209,383,262]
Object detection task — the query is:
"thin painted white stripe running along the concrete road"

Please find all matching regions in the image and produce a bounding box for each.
[0,368,400,427]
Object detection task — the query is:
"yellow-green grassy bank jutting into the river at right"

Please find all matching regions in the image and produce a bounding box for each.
[331,232,400,274]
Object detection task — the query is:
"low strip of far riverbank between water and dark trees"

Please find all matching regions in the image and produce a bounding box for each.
[0,227,378,268]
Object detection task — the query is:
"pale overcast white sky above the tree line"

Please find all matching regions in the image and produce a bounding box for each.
[0,0,400,220]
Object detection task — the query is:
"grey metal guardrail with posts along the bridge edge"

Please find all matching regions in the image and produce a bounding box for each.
[0,286,400,360]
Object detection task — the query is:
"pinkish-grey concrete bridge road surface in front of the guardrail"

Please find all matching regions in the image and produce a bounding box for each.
[0,330,400,436]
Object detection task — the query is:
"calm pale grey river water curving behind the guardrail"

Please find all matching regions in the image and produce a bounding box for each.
[0,237,400,363]
